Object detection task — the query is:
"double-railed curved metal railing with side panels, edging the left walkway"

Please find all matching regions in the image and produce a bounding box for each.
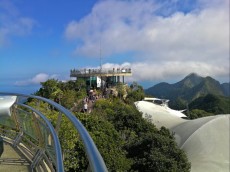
[0,92,107,172]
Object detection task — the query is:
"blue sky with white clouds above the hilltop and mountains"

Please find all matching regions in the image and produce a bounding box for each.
[0,0,230,93]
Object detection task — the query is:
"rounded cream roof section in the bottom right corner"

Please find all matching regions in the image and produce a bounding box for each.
[171,115,230,172]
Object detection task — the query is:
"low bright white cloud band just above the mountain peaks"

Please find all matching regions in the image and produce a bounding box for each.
[102,61,228,82]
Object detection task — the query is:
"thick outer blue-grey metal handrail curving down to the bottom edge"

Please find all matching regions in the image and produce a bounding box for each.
[0,92,108,172]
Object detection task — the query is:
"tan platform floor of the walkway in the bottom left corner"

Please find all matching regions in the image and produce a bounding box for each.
[0,142,32,172]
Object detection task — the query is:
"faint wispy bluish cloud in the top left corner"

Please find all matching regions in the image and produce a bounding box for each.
[0,0,37,47]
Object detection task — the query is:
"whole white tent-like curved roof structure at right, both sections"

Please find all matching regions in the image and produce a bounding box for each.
[135,101,230,172]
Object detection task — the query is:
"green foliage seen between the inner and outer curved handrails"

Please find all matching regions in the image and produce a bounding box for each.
[26,100,82,171]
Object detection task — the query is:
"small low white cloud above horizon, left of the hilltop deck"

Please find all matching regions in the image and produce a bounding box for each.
[15,73,58,86]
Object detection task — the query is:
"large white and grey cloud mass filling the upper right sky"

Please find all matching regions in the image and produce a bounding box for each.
[65,0,229,80]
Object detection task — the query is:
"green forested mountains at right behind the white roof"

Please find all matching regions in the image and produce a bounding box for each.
[146,73,230,119]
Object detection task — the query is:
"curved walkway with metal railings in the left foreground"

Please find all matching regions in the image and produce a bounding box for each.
[0,92,108,172]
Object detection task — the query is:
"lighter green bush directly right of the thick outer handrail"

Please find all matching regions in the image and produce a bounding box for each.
[77,113,132,171]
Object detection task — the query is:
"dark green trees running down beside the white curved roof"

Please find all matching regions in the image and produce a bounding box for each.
[91,100,190,171]
